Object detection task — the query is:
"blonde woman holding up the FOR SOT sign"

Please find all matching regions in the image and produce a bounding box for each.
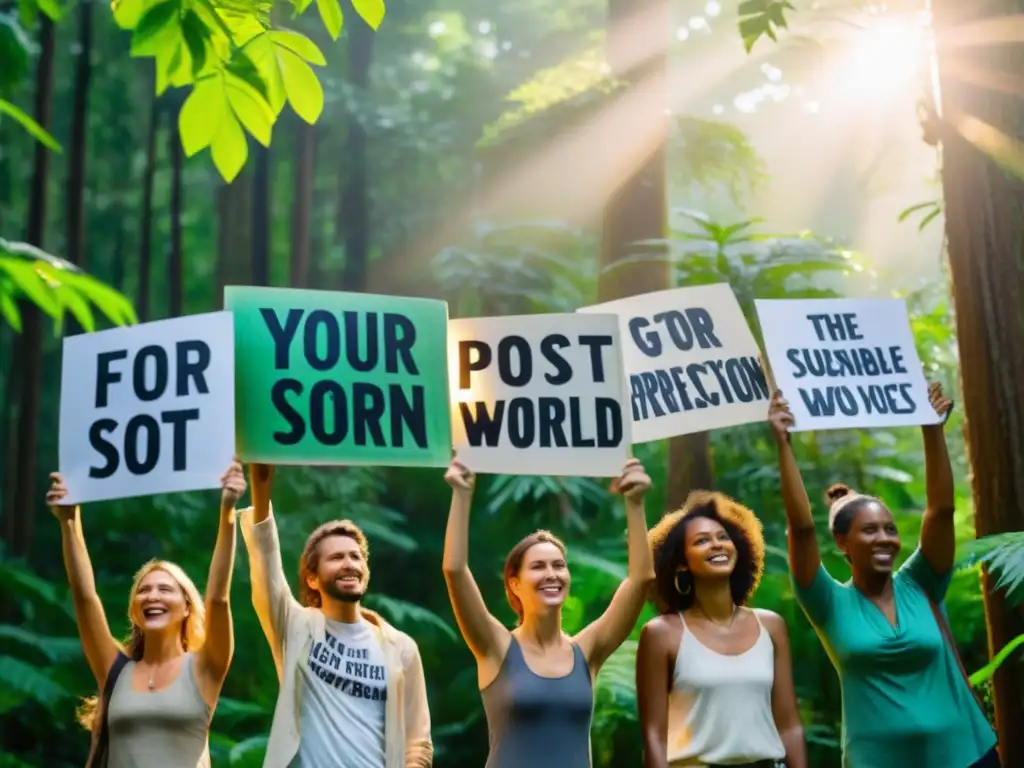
[46,462,246,768]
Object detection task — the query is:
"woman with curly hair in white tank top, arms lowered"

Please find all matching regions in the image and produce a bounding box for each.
[637,490,807,768]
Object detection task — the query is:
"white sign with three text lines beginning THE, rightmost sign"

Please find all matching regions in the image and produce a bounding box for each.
[755,299,940,431]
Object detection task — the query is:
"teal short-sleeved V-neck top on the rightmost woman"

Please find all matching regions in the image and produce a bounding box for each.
[794,549,995,768]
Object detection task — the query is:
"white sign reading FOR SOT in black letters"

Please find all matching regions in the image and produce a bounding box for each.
[59,312,234,504]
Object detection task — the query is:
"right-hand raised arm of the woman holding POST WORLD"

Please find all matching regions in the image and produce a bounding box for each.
[575,459,654,677]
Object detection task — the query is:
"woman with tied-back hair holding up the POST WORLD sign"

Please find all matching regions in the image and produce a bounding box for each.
[443,459,654,768]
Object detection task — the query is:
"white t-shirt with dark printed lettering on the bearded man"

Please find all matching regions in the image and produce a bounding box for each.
[292,618,387,768]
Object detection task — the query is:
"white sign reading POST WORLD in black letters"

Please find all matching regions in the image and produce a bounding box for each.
[449,314,630,477]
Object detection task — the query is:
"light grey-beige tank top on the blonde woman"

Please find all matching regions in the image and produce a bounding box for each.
[106,653,210,768]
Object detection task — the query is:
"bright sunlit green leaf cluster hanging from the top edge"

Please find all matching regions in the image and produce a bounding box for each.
[113,0,385,181]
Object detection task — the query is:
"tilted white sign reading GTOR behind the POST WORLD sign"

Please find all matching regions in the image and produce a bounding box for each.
[578,283,770,442]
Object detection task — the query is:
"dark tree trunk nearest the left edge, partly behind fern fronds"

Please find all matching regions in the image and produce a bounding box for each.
[4,16,54,557]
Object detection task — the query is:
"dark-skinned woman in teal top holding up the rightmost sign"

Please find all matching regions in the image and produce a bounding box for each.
[768,384,999,768]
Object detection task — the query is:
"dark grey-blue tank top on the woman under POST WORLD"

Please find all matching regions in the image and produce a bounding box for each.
[480,636,594,768]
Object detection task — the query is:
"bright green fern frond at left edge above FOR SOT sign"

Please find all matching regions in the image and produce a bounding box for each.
[0,240,137,334]
